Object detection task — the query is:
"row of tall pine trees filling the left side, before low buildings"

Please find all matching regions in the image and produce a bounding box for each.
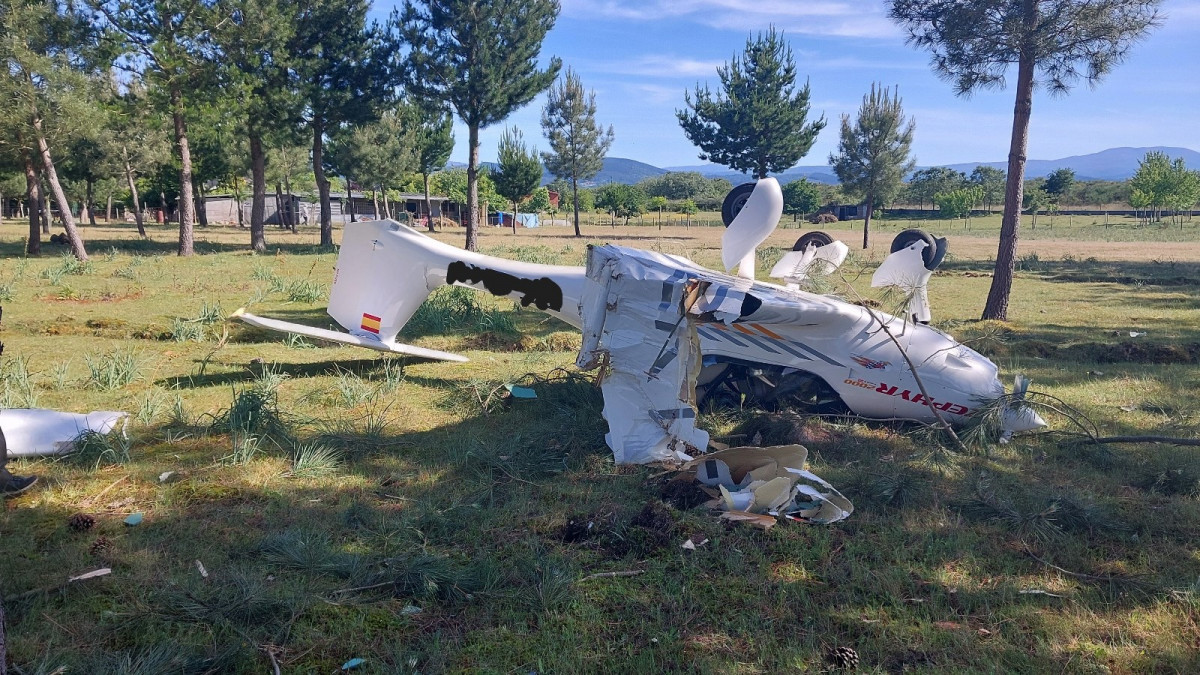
[0,0,613,259]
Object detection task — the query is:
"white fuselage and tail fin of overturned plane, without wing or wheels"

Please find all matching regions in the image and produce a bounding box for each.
[329,221,1004,422]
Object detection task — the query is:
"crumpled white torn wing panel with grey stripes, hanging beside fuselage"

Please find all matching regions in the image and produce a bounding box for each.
[577,246,708,464]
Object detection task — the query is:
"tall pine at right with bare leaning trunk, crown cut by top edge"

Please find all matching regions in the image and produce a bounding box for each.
[889,0,1162,319]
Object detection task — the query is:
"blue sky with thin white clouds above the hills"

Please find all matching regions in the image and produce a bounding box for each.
[388,0,1200,167]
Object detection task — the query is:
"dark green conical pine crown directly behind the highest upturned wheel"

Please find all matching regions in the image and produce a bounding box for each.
[676,26,826,178]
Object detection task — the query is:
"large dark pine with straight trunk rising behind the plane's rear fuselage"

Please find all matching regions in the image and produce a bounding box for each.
[392,0,562,251]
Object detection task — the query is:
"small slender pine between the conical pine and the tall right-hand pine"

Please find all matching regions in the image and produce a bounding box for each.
[829,84,917,249]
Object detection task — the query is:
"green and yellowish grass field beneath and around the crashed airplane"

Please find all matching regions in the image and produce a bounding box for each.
[0,216,1200,675]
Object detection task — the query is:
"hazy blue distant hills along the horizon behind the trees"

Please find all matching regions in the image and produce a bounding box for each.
[450,147,1200,187]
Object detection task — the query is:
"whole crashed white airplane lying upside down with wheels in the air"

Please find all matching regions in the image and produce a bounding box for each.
[235,178,1044,464]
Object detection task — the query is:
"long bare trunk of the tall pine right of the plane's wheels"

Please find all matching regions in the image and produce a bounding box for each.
[982,9,1038,321]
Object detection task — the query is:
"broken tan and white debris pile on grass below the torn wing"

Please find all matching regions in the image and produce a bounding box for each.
[684,446,854,528]
